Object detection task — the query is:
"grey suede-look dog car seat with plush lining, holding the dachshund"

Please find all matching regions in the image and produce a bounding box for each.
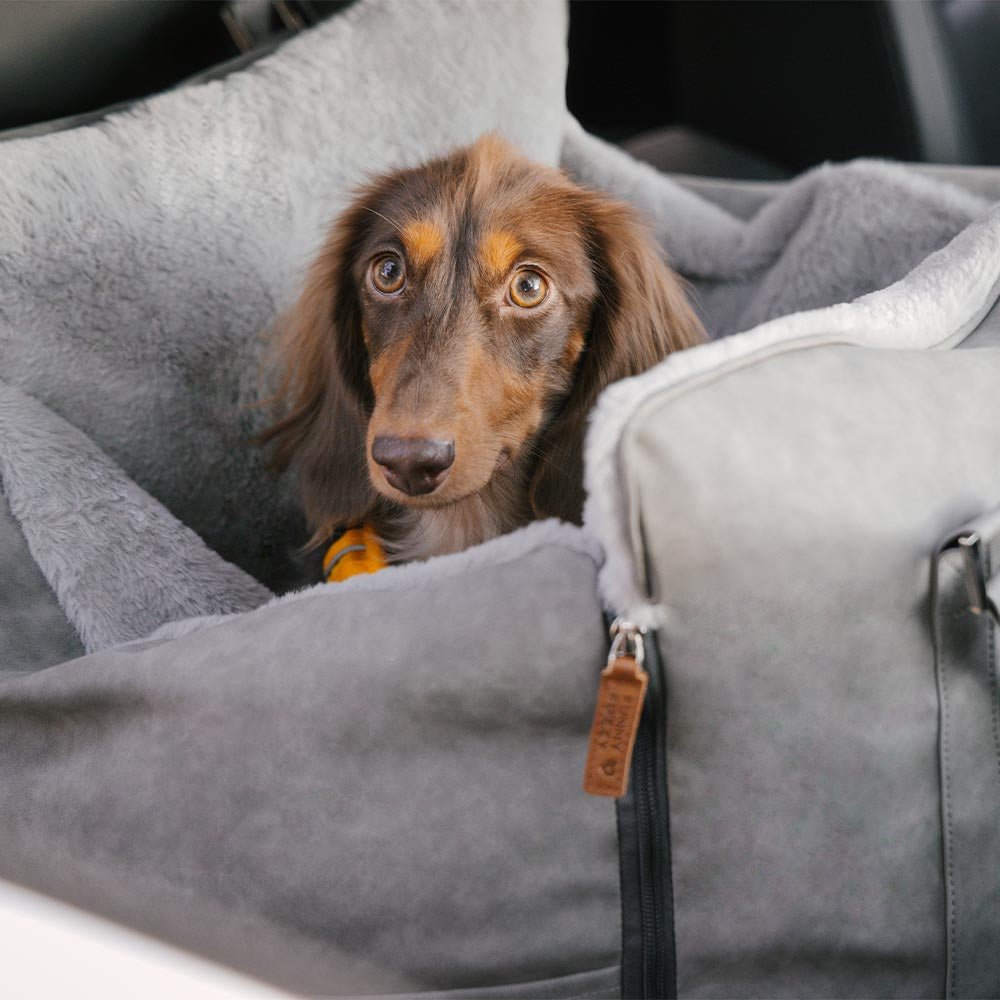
[0,3,1000,997]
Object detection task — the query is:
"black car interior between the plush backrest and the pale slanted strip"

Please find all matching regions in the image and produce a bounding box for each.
[566,0,919,171]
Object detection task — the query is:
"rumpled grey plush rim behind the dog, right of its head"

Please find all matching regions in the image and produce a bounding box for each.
[562,123,1000,338]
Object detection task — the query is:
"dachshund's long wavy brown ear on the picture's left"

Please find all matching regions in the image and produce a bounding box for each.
[257,198,376,545]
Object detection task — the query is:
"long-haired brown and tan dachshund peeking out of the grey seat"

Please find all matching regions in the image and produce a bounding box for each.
[262,134,704,561]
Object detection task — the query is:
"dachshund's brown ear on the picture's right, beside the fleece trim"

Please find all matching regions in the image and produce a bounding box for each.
[529,191,705,523]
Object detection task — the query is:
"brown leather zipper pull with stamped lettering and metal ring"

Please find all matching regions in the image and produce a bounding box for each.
[583,618,649,799]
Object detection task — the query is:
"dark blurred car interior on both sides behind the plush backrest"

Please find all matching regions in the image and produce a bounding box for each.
[0,0,1000,178]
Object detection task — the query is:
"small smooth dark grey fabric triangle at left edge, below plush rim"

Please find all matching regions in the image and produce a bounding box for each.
[0,479,83,673]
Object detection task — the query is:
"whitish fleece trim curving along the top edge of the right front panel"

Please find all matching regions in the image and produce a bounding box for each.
[584,199,1000,627]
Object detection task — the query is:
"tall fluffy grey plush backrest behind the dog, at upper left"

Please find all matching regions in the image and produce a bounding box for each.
[0,0,566,586]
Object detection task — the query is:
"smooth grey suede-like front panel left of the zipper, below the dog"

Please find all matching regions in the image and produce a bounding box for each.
[0,529,620,995]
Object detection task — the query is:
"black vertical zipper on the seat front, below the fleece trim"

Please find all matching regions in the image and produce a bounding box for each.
[617,635,677,1000]
